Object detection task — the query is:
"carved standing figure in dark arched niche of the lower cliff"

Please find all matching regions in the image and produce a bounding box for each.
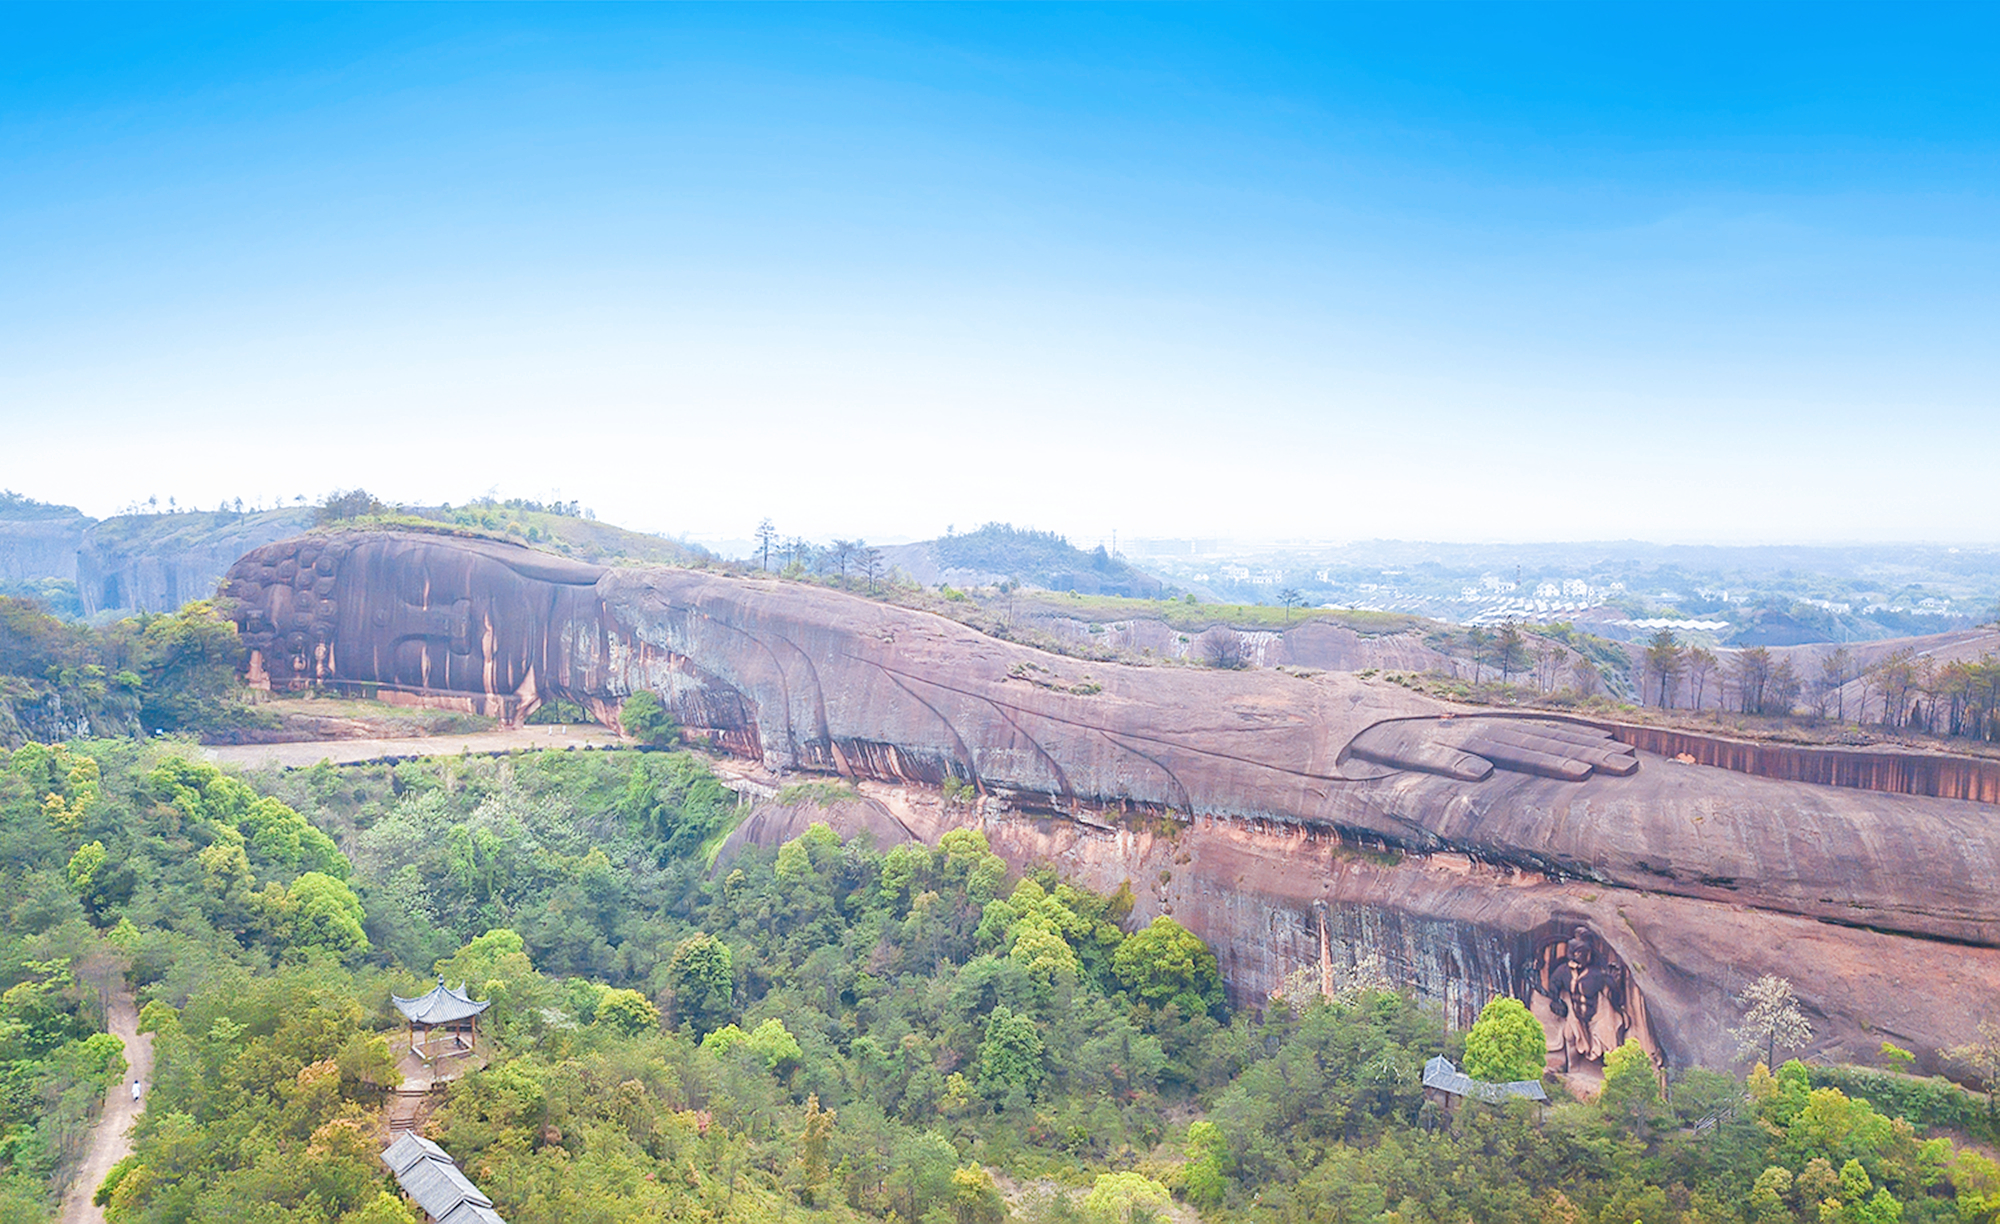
[1522,922,1660,1074]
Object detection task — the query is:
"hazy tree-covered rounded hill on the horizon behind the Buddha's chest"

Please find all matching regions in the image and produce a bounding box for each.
[882,522,1166,600]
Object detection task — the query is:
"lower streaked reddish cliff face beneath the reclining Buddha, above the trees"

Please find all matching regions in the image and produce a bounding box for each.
[964,814,2000,1070]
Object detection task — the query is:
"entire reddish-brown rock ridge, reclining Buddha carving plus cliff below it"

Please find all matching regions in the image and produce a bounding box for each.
[230,534,2000,1072]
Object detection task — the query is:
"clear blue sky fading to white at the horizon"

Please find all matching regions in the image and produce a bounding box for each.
[0,4,2000,542]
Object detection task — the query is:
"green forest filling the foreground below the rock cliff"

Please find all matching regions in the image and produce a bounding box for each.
[0,740,2000,1224]
